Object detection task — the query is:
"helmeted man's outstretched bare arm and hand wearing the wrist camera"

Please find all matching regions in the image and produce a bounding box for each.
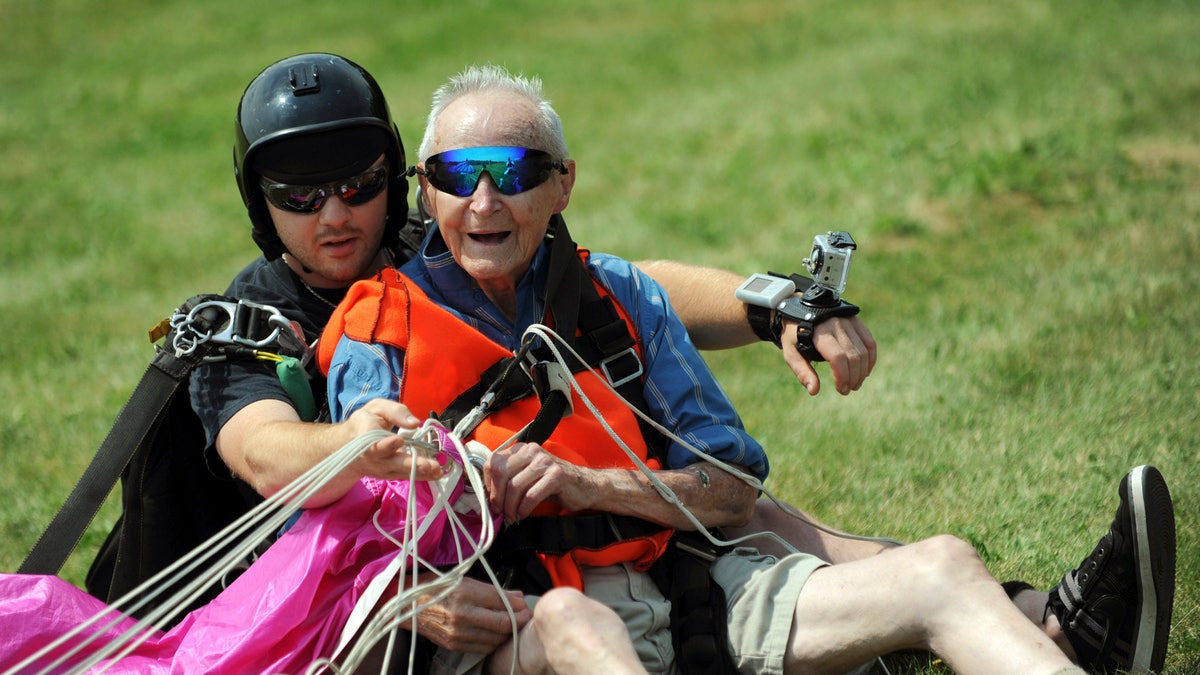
[637,261,878,395]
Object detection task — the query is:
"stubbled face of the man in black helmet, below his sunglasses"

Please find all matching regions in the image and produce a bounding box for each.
[264,156,388,288]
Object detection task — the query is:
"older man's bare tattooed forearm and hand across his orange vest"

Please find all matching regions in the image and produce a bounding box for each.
[484,443,757,530]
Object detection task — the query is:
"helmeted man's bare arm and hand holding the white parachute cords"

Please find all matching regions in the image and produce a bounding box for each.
[216,399,442,508]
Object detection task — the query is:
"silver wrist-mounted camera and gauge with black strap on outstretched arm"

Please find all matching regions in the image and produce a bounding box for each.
[736,232,858,362]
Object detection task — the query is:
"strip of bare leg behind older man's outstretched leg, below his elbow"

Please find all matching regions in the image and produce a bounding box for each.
[722,497,894,565]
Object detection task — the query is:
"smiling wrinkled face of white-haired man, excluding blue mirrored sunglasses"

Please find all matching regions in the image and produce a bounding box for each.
[421,92,575,294]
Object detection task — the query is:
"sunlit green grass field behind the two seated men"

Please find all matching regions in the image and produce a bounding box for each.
[0,0,1200,673]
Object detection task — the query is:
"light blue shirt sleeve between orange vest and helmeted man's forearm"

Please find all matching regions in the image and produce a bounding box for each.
[328,335,404,422]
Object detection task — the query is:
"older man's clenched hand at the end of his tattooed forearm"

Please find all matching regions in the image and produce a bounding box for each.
[484,443,596,522]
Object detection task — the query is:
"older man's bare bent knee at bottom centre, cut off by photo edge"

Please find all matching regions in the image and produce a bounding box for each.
[488,589,646,675]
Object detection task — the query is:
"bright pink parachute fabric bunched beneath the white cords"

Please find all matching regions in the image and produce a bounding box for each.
[0,427,494,674]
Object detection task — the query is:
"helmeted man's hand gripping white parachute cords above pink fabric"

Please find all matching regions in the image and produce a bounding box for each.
[342,399,442,480]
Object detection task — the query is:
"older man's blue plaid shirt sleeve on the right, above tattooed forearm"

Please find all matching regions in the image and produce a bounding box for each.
[589,253,769,480]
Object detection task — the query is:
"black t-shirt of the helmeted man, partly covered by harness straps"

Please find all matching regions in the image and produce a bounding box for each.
[188,257,347,447]
